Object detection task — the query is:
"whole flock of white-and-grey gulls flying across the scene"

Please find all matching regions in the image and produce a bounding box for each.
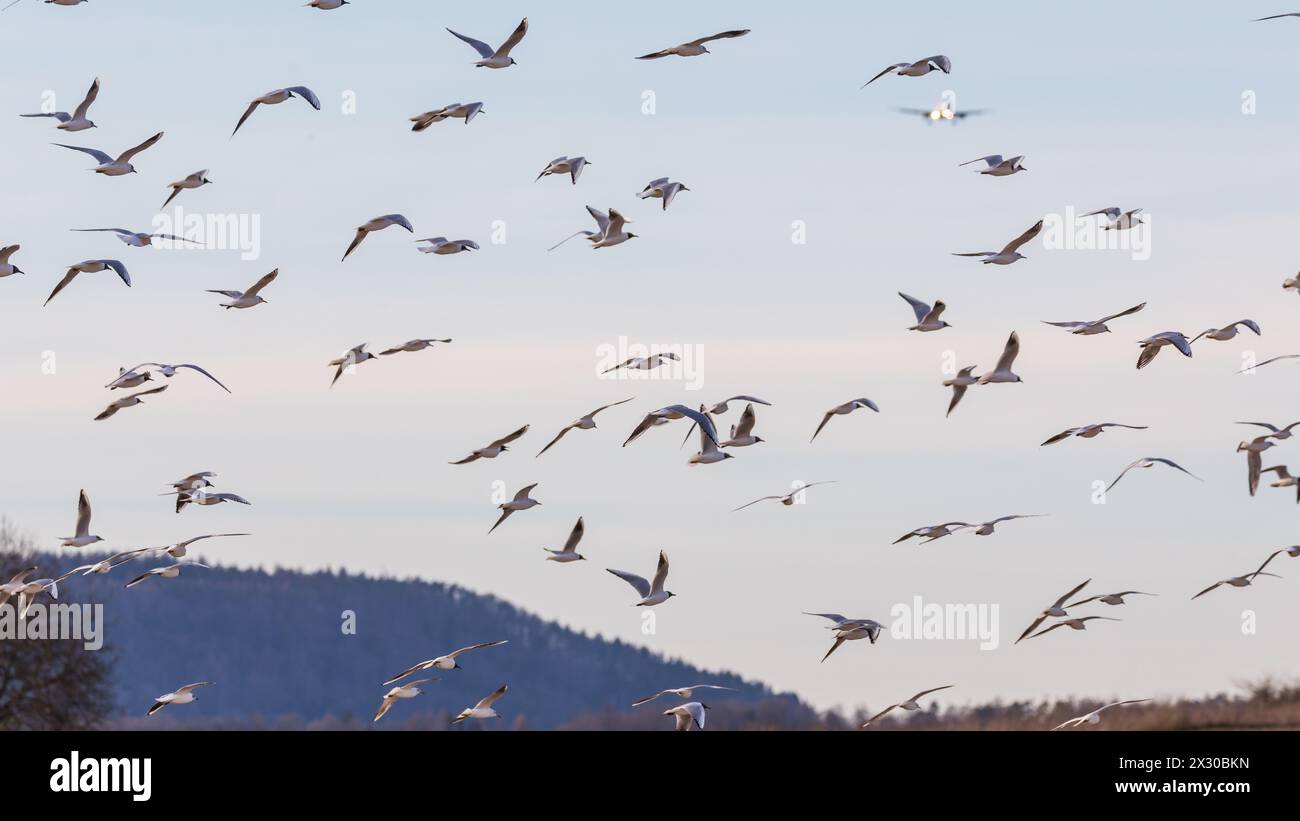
[0,6,1300,730]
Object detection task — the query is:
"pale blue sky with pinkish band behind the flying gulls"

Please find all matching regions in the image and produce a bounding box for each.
[0,0,1300,708]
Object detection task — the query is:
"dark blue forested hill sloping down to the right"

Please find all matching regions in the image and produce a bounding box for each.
[15,553,813,729]
